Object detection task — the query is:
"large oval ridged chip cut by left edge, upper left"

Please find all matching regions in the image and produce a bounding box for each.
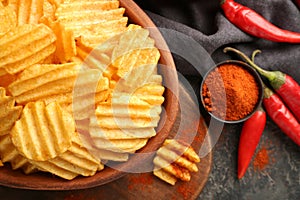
[0,24,56,74]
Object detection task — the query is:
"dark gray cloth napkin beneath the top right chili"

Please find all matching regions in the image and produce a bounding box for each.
[136,0,300,83]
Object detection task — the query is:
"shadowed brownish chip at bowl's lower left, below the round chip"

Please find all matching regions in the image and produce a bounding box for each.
[0,134,37,174]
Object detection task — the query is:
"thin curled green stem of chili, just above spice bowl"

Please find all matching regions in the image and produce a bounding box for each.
[224,47,276,81]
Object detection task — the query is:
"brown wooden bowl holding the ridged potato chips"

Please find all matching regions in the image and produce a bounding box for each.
[0,0,178,190]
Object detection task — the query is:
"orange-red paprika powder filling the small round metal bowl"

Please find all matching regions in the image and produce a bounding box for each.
[202,63,259,121]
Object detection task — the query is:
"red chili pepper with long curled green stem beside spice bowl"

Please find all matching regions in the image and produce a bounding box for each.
[224,47,300,122]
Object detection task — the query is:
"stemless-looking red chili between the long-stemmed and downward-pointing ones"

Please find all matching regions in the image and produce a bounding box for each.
[263,86,300,146]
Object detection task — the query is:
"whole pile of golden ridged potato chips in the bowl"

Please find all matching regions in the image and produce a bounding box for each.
[0,0,164,180]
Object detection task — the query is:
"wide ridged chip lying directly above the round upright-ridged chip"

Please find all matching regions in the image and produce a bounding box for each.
[8,63,81,104]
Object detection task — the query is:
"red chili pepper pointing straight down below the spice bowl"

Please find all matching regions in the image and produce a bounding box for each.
[238,108,267,179]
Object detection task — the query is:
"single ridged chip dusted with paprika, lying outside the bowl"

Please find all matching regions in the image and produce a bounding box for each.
[153,139,200,185]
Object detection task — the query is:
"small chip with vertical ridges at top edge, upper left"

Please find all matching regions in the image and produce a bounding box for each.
[16,0,44,26]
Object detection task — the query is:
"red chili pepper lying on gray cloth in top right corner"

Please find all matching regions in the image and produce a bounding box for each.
[221,0,300,43]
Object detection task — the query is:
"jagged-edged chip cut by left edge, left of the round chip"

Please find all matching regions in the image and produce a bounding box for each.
[0,87,22,135]
